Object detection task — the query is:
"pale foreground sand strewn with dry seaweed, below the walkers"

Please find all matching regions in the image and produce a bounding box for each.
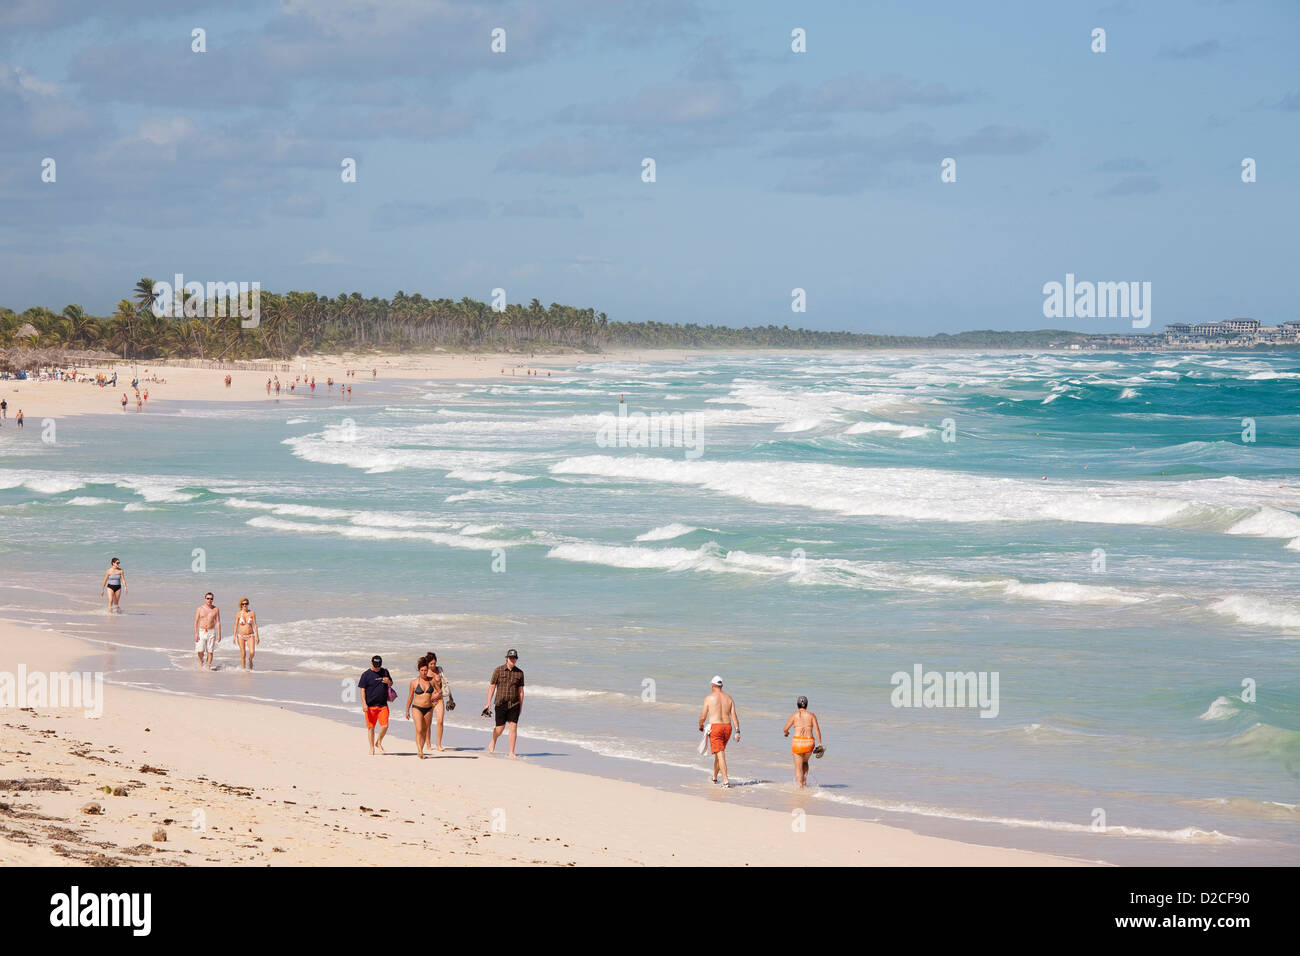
[0,622,1075,866]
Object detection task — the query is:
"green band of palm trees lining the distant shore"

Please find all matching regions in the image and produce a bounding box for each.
[0,278,1084,360]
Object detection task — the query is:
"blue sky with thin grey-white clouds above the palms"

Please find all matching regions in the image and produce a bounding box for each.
[0,0,1300,334]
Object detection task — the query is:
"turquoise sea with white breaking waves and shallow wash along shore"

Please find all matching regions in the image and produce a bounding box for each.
[0,352,1300,864]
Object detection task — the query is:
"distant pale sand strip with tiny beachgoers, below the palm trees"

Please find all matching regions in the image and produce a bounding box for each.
[0,349,707,427]
